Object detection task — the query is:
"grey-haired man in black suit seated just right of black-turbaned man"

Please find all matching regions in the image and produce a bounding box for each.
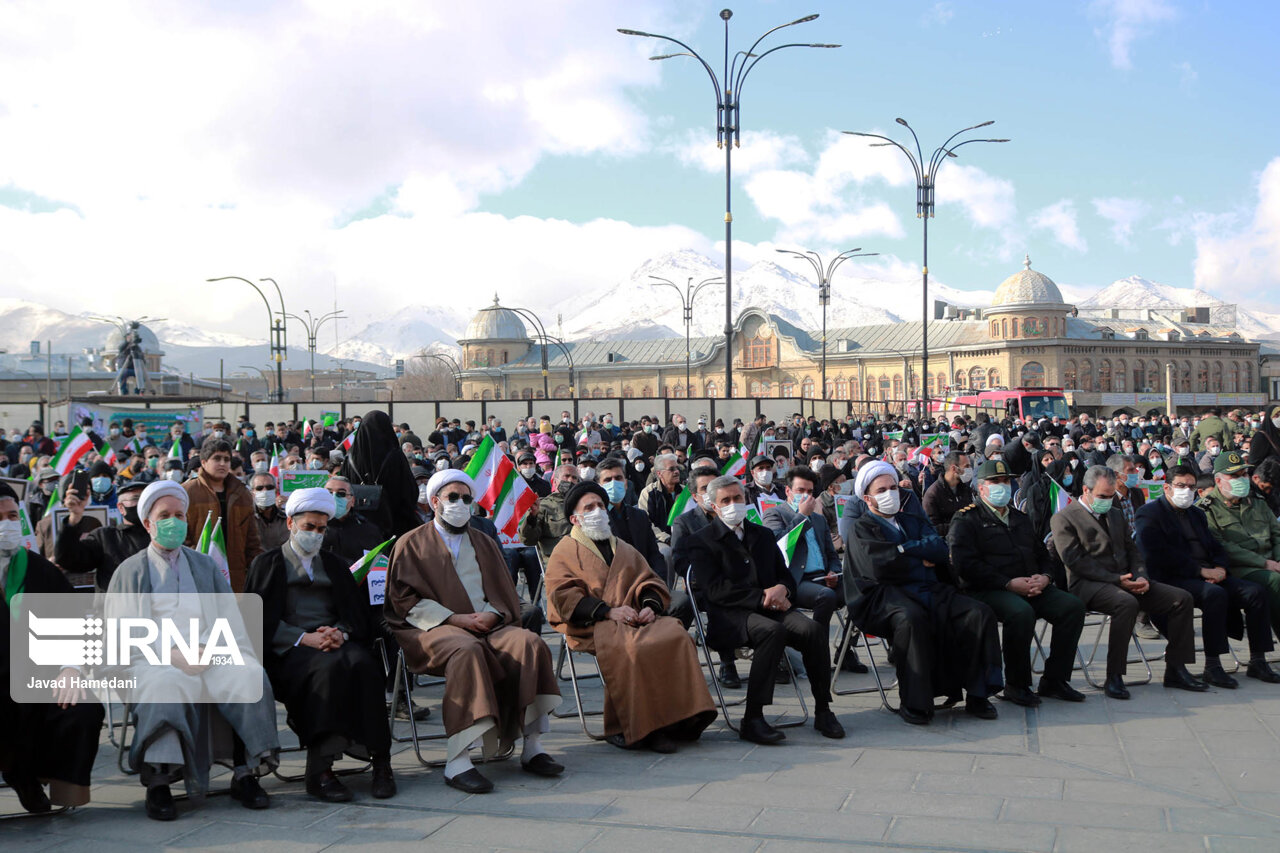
[689,476,845,744]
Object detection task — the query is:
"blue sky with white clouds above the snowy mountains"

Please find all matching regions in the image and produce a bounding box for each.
[0,0,1280,345]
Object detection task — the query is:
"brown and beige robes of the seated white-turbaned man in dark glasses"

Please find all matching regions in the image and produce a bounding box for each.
[384,524,561,758]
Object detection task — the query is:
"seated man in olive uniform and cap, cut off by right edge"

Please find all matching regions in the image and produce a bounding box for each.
[1197,451,1280,648]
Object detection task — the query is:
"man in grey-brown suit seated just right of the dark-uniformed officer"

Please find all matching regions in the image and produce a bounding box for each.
[1050,465,1208,699]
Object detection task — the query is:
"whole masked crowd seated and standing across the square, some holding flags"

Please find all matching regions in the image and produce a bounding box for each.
[0,407,1280,820]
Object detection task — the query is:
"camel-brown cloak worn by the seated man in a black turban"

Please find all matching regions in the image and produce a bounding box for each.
[545,528,716,744]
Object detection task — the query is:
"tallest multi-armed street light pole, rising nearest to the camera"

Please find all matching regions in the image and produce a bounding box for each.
[618,9,840,398]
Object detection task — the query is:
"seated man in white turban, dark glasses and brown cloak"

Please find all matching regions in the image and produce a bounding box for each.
[385,469,564,794]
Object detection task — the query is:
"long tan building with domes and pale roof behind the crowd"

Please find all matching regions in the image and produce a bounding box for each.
[458,256,1267,415]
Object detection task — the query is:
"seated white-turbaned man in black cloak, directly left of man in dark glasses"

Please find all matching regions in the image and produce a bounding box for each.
[244,488,396,803]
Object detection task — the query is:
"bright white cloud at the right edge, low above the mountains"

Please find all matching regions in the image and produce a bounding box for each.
[1196,158,1280,301]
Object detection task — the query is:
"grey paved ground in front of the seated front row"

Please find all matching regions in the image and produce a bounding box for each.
[0,627,1280,853]
